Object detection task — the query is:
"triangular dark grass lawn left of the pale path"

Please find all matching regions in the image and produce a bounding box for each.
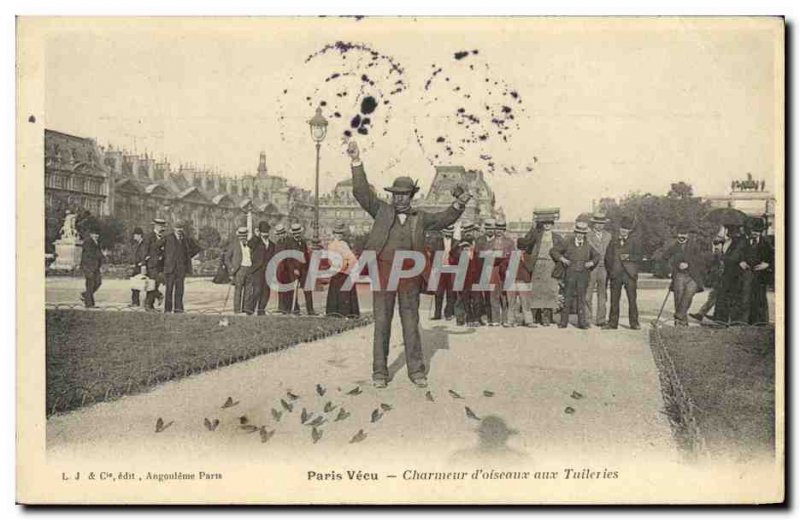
[46,310,369,415]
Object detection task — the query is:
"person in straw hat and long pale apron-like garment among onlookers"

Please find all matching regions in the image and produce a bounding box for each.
[517,208,563,327]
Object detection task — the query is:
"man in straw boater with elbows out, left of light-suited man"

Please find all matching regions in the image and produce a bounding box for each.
[550,220,600,329]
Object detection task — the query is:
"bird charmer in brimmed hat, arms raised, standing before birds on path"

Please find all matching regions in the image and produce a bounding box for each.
[347,141,471,388]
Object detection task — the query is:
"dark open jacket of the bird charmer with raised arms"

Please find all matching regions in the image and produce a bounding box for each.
[352,161,464,253]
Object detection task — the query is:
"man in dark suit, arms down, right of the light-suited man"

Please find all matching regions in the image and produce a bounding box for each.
[603,216,642,330]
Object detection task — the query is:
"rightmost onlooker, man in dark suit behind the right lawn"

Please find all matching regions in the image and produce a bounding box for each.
[737,218,775,325]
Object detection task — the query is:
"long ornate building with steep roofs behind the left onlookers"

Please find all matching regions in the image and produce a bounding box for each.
[45,130,314,245]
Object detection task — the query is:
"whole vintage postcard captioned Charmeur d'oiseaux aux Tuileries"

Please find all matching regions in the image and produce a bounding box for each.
[16,17,786,504]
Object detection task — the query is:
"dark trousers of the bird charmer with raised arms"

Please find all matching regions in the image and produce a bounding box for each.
[372,283,425,380]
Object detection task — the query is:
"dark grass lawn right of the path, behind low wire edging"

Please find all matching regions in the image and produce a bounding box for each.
[659,327,775,458]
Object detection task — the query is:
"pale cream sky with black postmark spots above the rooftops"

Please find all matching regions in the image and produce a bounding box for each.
[45,18,783,219]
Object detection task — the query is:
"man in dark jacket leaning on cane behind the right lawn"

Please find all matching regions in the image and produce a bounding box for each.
[665,224,709,327]
